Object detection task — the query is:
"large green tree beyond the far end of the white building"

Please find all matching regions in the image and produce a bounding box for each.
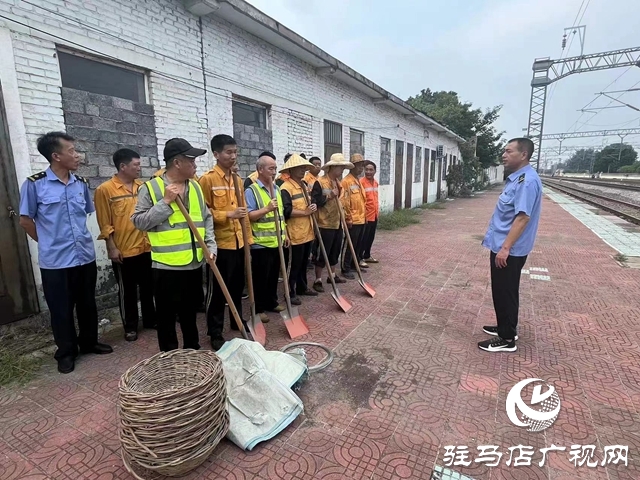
[407,88,504,169]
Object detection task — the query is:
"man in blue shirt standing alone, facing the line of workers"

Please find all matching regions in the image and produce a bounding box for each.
[478,138,542,352]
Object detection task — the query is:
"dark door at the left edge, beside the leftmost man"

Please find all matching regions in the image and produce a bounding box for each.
[0,85,38,325]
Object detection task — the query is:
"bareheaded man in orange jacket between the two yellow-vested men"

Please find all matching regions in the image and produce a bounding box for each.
[198,135,251,350]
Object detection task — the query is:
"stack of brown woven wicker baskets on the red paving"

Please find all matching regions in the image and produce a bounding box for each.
[118,350,229,478]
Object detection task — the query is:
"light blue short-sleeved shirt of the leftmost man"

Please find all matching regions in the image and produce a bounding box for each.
[20,168,96,269]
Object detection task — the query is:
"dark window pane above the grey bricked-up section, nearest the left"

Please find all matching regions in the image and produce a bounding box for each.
[58,51,147,103]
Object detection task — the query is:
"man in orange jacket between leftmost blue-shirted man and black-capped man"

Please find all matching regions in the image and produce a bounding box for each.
[95,148,156,342]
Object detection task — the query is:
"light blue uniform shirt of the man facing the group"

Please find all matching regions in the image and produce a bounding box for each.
[482,165,542,257]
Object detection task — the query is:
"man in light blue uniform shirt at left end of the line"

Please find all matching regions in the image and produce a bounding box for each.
[20,132,113,373]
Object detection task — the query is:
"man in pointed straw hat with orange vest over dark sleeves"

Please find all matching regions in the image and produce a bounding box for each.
[280,153,318,305]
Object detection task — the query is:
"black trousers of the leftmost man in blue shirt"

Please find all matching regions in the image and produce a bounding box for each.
[40,261,98,361]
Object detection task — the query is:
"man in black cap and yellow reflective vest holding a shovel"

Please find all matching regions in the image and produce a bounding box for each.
[131,138,217,352]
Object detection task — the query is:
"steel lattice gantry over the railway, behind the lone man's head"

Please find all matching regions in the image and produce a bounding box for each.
[527,47,640,170]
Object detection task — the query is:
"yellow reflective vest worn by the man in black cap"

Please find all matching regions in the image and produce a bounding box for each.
[146,177,207,267]
